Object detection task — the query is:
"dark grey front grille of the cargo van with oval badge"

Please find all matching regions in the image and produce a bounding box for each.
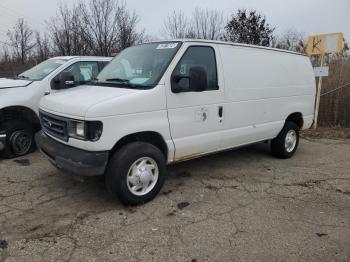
[40,111,68,142]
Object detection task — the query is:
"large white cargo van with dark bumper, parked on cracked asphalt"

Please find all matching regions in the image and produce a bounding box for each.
[36,40,315,204]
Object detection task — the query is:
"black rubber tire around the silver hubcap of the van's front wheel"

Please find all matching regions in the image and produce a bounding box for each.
[105,142,166,205]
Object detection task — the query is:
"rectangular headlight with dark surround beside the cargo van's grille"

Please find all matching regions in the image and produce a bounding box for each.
[68,120,103,141]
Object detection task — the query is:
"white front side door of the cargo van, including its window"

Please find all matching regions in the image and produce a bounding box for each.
[165,43,224,161]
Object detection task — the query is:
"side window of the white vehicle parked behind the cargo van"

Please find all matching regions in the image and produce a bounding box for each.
[64,62,98,84]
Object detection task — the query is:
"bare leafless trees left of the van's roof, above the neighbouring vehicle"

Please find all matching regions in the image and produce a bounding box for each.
[0,0,145,64]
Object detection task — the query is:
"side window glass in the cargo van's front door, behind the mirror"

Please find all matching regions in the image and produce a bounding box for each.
[173,46,219,92]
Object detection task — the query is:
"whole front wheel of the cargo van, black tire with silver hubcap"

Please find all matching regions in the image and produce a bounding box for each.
[106,142,166,205]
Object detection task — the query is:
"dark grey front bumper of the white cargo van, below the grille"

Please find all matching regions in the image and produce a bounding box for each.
[35,131,108,176]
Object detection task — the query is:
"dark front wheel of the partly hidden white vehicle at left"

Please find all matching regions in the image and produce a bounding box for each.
[1,119,35,158]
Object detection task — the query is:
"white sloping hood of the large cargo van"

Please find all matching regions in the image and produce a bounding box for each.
[40,85,140,117]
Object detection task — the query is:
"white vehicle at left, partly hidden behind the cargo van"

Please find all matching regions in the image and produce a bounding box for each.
[0,56,111,157]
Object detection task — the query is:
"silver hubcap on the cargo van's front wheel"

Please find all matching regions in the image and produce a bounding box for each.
[127,157,159,196]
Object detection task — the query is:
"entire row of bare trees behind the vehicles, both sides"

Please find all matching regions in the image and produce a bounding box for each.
[0,0,348,70]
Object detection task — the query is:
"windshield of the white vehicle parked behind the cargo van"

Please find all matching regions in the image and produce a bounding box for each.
[18,59,67,81]
